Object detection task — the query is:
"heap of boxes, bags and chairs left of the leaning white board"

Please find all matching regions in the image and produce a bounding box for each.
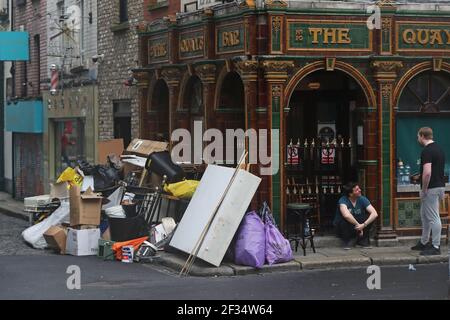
[22,139,198,262]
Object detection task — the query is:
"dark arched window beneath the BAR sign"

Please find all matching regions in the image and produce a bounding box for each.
[215,72,246,166]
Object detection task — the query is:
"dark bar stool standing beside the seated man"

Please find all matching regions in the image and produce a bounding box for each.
[286,202,316,256]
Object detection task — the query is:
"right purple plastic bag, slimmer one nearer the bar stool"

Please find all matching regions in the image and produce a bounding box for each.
[264,219,294,265]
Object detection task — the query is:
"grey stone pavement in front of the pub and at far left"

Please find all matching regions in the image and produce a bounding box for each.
[0,192,449,277]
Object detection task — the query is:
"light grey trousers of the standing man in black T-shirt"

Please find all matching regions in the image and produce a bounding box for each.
[420,188,445,248]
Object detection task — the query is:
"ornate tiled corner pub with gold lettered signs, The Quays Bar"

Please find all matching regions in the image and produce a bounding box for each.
[134,0,450,246]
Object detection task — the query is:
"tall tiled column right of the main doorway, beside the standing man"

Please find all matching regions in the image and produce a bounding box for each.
[372,60,403,246]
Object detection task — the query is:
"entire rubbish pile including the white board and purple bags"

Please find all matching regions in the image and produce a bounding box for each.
[22,139,293,274]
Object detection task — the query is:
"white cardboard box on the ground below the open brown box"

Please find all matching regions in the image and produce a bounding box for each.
[66,228,100,256]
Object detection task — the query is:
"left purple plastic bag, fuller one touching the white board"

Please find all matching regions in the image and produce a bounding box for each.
[234,211,266,268]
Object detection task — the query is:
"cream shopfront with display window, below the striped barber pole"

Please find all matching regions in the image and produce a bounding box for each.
[43,85,98,190]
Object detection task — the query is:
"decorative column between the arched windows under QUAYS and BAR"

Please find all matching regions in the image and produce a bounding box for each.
[195,63,217,130]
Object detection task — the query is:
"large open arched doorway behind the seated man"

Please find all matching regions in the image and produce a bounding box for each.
[283,70,368,234]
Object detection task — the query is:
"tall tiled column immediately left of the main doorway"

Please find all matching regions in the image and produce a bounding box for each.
[262,61,294,225]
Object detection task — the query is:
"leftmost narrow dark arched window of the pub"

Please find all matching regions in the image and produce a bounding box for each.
[149,79,170,141]
